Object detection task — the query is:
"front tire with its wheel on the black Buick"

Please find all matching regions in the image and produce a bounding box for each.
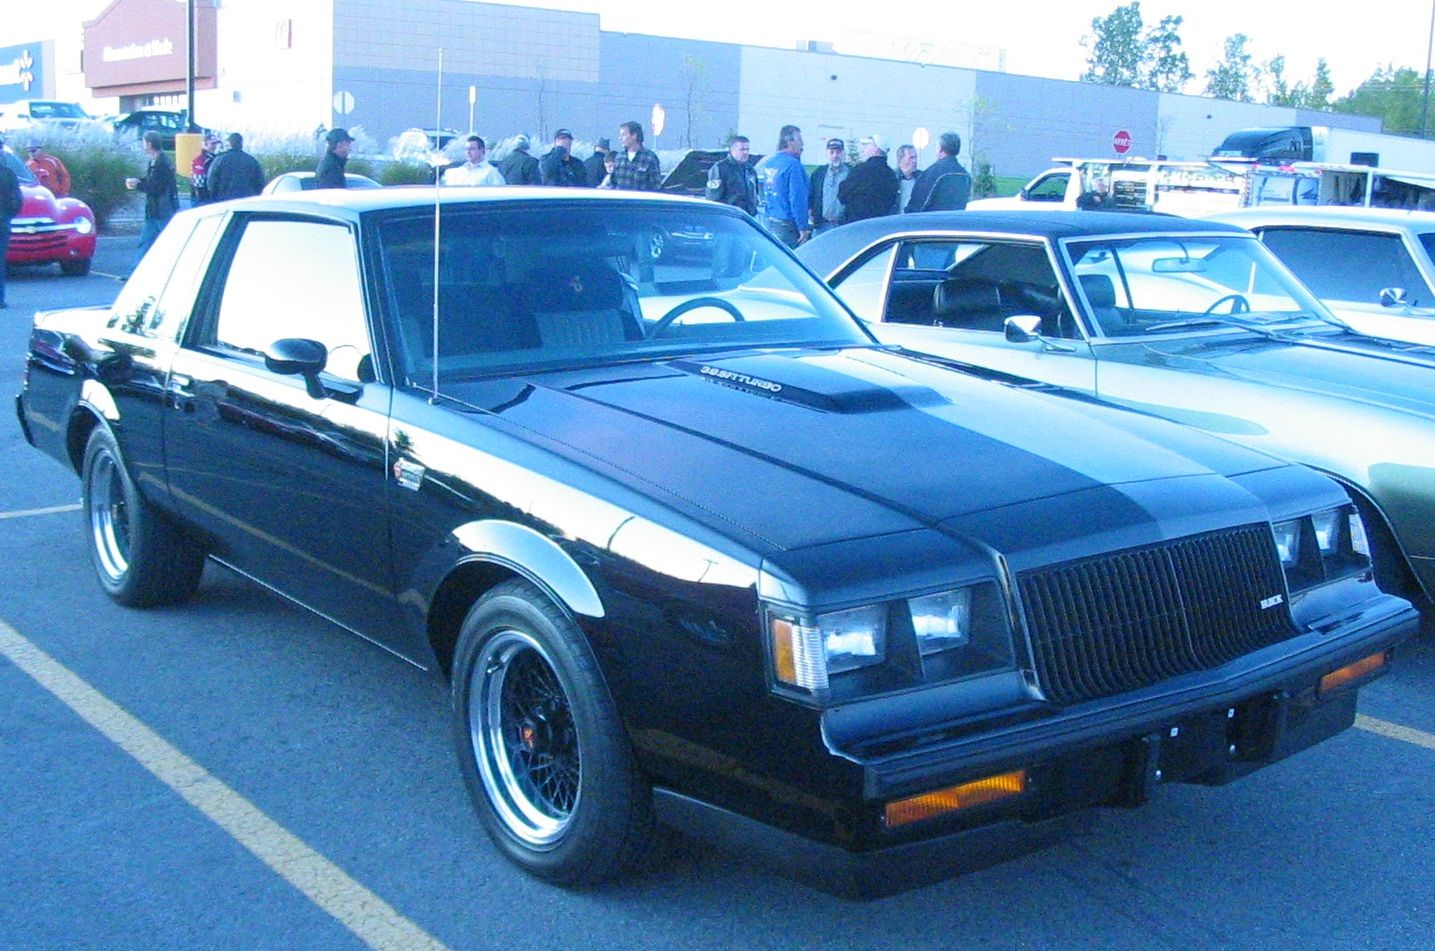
[452,581,659,886]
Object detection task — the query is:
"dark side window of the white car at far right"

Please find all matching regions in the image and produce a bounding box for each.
[1261,228,1431,304]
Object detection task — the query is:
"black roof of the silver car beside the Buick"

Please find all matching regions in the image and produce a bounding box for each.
[798,208,1247,274]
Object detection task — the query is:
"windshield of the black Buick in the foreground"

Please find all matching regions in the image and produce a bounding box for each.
[379,202,872,386]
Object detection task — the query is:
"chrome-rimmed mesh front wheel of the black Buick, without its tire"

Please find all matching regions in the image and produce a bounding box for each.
[468,628,581,849]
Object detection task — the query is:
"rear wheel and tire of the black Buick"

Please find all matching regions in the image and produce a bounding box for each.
[80,426,205,608]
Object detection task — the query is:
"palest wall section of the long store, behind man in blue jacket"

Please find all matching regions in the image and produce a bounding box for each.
[738,46,976,165]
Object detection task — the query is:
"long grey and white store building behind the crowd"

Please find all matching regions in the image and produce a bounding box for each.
[0,0,1380,175]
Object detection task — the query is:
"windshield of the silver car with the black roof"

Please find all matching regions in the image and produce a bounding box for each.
[1065,234,1339,337]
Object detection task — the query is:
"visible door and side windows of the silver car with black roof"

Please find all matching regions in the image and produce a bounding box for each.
[831,235,1096,393]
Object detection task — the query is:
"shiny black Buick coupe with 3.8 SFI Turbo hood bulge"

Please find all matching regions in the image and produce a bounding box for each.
[19,188,1415,894]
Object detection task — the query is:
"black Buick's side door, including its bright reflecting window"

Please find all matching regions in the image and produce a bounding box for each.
[165,215,396,631]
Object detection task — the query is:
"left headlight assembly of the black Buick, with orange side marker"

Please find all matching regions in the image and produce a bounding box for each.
[768,582,1015,701]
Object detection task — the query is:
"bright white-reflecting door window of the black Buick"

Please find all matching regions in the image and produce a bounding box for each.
[214,219,372,382]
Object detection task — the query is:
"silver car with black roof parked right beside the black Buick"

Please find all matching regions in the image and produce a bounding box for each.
[798,211,1435,625]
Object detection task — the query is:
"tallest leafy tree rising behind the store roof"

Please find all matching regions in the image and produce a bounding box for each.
[1081,0,1192,92]
